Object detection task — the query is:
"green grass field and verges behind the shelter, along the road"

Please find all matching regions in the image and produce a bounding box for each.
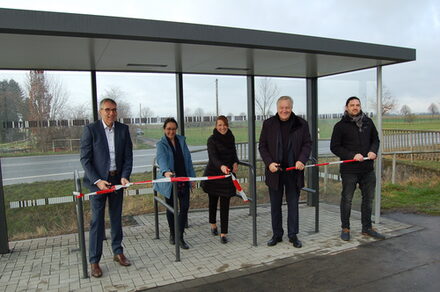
[3,116,440,240]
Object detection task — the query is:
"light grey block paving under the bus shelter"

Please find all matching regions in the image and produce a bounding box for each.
[0,204,419,291]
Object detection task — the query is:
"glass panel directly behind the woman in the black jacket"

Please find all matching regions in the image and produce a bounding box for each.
[183,75,248,208]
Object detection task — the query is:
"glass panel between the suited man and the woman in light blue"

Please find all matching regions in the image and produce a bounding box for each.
[96,72,177,218]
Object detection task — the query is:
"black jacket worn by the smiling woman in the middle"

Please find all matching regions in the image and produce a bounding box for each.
[201,129,238,196]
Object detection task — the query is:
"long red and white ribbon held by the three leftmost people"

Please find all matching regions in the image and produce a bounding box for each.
[73,173,249,202]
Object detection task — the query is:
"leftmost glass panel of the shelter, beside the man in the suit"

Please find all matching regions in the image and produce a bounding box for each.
[0,71,92,240]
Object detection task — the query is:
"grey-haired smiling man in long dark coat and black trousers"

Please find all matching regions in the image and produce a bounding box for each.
[258,96,312,248]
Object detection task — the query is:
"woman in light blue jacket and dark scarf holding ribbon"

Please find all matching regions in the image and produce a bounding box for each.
[154,118,195,249]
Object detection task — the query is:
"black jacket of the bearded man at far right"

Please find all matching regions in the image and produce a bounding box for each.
[330,115,380,173]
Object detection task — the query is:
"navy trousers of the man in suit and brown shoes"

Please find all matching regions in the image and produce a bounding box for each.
[89,177,123,264]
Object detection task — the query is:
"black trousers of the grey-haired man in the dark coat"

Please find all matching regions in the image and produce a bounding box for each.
[269,174,300,238]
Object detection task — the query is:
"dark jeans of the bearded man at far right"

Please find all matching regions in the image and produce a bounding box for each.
[341,171,376,231]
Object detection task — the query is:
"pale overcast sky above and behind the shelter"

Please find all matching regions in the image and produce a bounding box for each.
[0,0,440,114]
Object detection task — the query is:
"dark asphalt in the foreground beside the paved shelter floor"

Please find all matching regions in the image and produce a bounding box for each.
[148,213,440,292]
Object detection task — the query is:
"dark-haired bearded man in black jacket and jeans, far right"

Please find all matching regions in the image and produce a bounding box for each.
[330,96,385,241]
